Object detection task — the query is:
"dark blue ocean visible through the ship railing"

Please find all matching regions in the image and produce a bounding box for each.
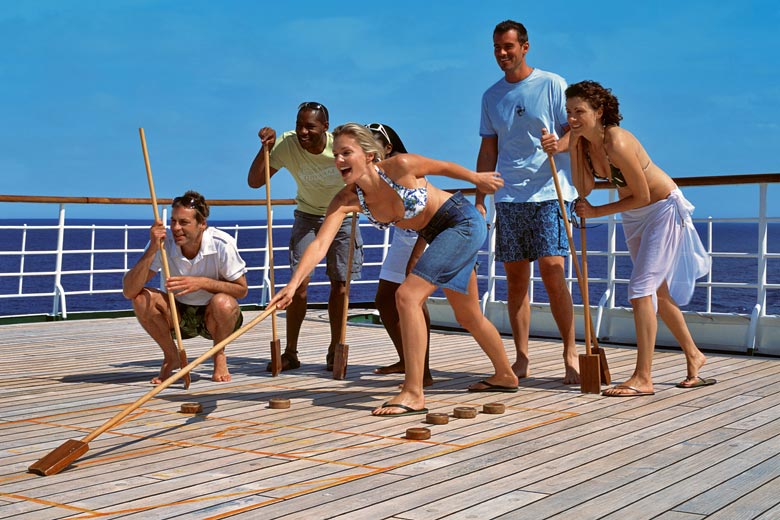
[0,219,780,316]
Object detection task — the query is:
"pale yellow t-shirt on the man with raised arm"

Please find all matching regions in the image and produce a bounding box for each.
[270,134,344,216]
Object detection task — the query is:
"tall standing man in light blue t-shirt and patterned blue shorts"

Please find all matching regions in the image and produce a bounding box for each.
[476,20,579,384]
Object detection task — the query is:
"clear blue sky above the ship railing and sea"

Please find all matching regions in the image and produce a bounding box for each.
[0,0,780,218]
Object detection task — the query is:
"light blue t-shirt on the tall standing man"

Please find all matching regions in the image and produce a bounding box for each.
[479,69,577,202]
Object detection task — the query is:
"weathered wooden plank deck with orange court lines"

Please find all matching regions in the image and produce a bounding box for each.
[0,311,780,520]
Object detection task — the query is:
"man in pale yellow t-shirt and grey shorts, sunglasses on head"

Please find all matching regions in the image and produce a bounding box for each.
[247,101,363,370]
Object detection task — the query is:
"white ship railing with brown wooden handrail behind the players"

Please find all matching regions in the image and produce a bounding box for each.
[0,174,780,354]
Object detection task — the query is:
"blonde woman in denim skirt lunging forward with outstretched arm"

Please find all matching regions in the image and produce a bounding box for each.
[269,123,517,416]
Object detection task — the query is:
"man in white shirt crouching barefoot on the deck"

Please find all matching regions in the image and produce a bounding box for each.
[122,191,248,385]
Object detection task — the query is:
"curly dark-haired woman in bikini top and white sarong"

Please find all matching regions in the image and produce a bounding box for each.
[566,81,715,397]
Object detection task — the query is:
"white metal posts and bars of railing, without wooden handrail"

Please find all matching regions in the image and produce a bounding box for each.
[0,182,780,334]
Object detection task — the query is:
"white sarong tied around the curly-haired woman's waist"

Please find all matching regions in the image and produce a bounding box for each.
[622,189,711,311]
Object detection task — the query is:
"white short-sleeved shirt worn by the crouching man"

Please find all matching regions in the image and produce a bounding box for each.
[146,227,246,305]
